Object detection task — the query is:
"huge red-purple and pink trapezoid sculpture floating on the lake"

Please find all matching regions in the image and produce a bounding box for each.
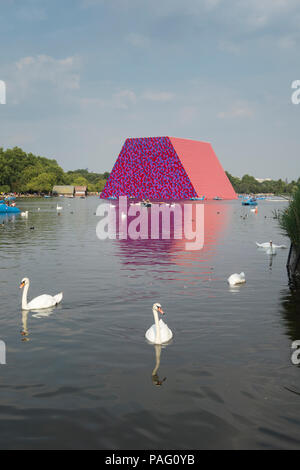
[100,137,237,200]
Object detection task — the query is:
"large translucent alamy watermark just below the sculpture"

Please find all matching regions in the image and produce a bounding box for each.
[96,196,204,250]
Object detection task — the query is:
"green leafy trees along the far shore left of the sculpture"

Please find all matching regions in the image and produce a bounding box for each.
[0,147,109,194]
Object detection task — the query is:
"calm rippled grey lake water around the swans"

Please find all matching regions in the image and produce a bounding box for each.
[0,198,300,449]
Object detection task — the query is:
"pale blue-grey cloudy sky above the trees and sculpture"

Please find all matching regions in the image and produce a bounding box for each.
[0,0,300,181]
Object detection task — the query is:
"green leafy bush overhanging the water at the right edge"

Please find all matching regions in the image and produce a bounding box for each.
[279,186,300,248]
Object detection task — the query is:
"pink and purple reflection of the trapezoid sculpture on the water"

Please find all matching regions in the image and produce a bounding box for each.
[114,201,234,284]
